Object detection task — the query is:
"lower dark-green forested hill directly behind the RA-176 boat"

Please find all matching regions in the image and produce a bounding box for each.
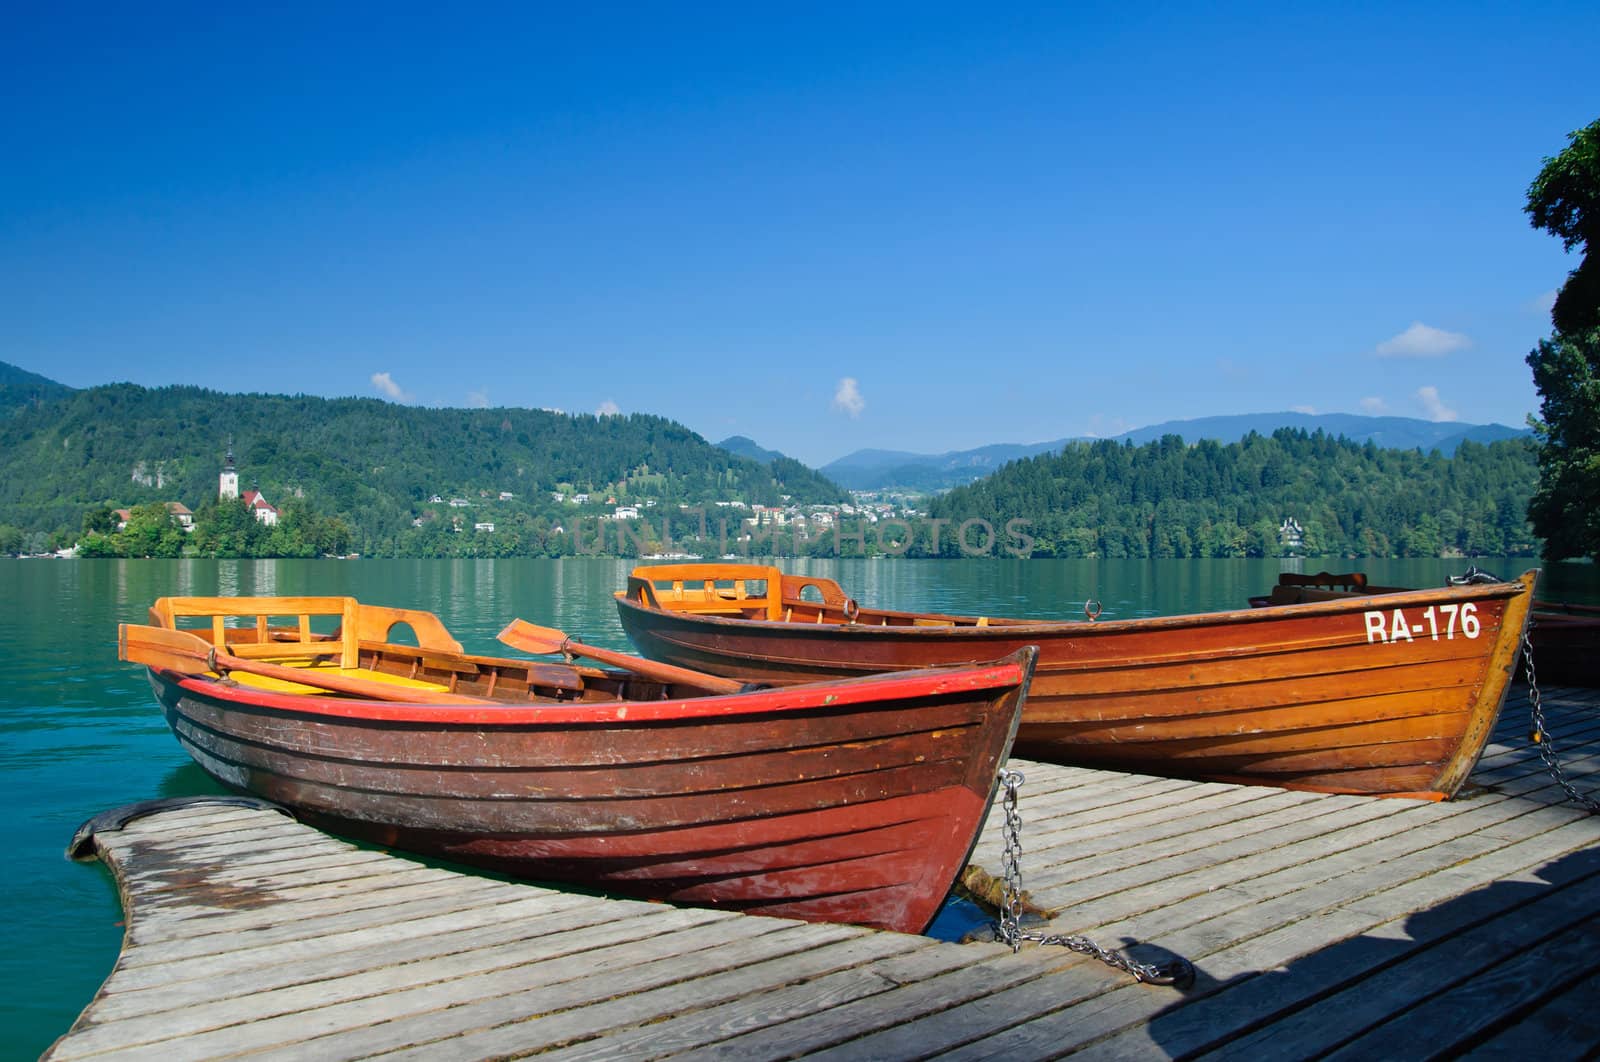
[931,429,1538,557]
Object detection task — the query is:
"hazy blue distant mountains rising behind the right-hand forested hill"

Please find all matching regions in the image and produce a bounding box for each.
[821,413,1528,491]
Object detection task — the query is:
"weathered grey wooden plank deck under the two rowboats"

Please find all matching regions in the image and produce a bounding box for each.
[45,688,1600,1062]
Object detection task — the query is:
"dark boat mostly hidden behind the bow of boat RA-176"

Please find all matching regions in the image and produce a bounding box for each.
[1250,569,1600,686]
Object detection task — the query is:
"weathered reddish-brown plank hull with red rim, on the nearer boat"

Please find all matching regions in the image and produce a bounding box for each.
[150,653,1032,932]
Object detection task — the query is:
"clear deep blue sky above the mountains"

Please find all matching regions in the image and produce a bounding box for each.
[0,3,1600,464]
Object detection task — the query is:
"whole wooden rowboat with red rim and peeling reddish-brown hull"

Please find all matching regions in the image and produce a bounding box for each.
[120,598,1035,932]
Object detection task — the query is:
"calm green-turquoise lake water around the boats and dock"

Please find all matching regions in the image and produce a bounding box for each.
[0,558,1600,1059]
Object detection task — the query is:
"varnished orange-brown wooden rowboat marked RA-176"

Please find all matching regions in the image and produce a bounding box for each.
[618,565,1536,798]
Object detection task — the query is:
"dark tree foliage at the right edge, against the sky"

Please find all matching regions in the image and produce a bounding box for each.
[1526,122,1600,561]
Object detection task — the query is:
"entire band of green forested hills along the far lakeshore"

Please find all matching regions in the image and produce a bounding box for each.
[0,366,1538,557]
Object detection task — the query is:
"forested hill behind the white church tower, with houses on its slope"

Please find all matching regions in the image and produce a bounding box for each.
[0,369,846,555]
